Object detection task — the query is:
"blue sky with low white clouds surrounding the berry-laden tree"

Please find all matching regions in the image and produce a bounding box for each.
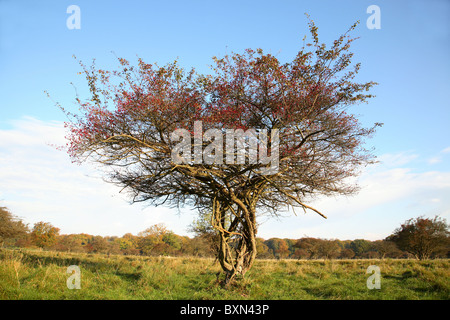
[0,0,450,239]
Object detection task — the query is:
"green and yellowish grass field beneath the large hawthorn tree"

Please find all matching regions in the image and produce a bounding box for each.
[0,249,450,300]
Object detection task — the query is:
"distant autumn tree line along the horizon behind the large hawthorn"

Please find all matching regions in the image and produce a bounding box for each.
[0,207,450,259]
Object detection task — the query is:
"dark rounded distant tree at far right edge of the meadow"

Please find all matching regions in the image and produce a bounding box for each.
[387,216,450,260]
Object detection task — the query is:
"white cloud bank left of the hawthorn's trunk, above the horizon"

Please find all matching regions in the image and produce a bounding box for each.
[0,118,197,236]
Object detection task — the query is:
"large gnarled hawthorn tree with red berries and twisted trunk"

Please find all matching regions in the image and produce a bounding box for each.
[62,20,378,283]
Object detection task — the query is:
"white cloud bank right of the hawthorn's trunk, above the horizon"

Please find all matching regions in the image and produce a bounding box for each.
[260,153,450,240]
